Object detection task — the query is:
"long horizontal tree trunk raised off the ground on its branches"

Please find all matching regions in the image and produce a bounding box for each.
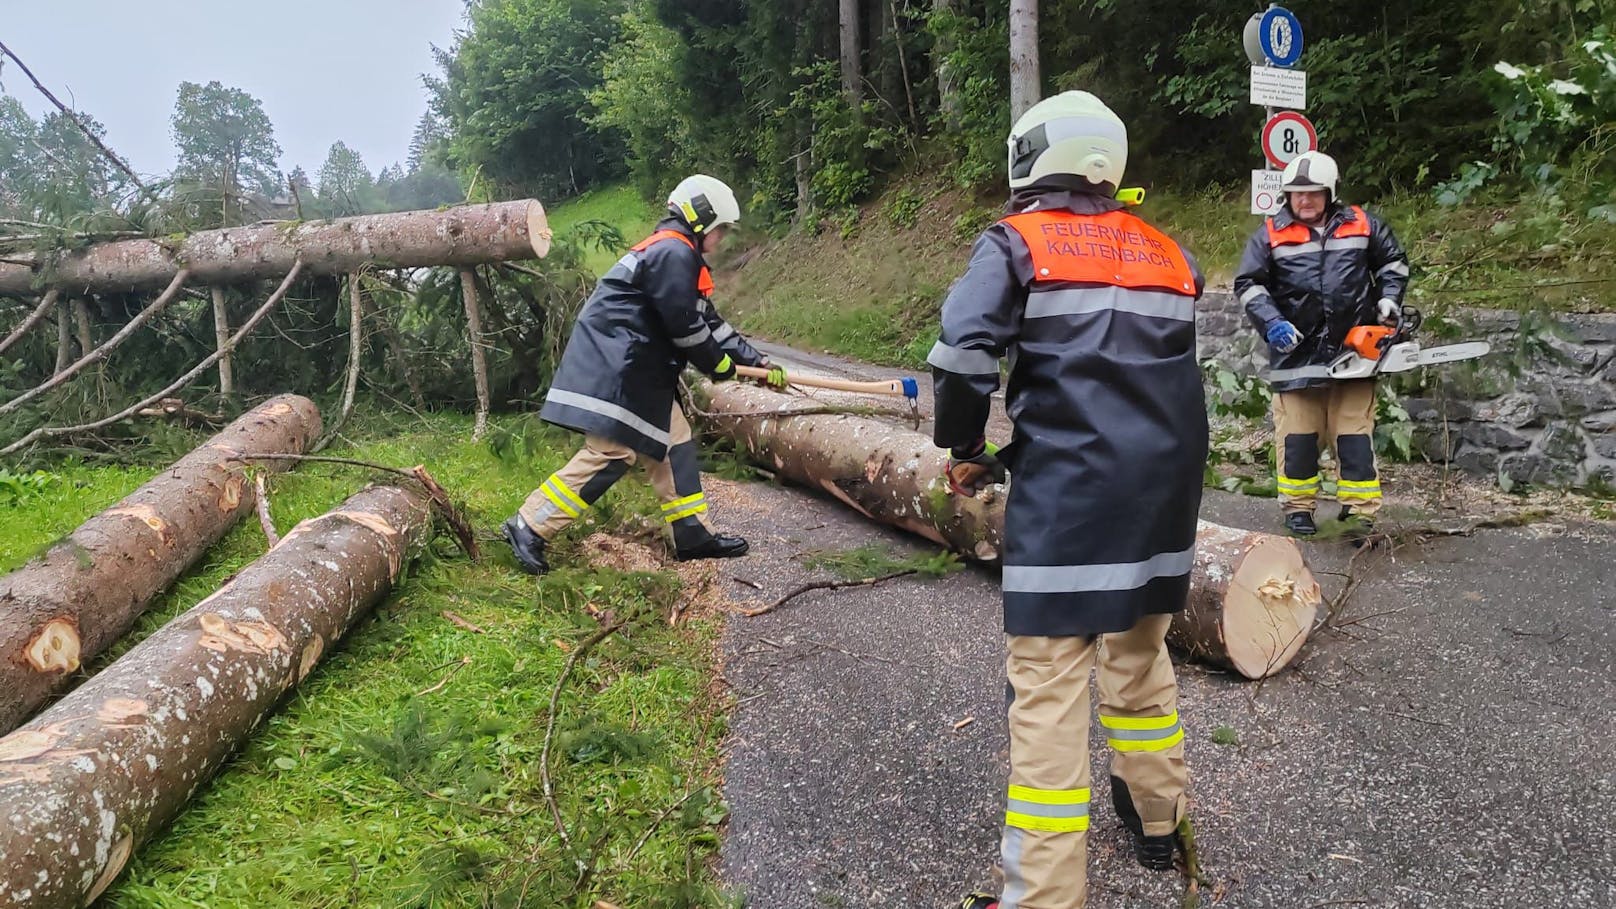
[0,199,549,294]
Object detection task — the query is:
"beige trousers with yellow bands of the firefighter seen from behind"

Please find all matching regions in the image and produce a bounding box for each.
[999,615,1189,909]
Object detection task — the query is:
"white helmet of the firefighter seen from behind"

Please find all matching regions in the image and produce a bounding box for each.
[1008,92,1128,196]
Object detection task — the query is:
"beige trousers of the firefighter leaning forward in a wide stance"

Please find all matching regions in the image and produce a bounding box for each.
[517,401,711,548]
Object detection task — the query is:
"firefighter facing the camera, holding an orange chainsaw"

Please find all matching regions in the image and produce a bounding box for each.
[1235,152,1409,537]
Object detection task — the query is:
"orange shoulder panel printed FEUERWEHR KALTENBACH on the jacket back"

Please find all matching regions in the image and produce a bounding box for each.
[1002,210,1196,296]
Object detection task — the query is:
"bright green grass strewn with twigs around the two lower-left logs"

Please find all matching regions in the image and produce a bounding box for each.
[0,409,730,909]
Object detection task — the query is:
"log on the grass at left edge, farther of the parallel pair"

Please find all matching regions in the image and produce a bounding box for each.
[0,395,320,733]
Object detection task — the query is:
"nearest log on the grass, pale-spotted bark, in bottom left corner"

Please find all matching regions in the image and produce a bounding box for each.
[0,487,431,909]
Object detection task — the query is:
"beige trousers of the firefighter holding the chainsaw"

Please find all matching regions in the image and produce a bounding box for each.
[1273,378,1380,518]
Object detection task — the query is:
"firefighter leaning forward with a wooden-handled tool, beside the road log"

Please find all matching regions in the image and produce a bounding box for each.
[504,175,785,574]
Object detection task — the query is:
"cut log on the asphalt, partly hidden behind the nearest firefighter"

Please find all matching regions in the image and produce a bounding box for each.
[703,383,1322,679]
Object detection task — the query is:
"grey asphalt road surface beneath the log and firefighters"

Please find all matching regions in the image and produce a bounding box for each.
[711,348,1616,909]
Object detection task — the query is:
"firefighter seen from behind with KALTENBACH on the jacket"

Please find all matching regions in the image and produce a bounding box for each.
[928,92,1207,909]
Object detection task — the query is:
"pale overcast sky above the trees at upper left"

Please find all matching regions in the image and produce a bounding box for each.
[0,0,464,176]
